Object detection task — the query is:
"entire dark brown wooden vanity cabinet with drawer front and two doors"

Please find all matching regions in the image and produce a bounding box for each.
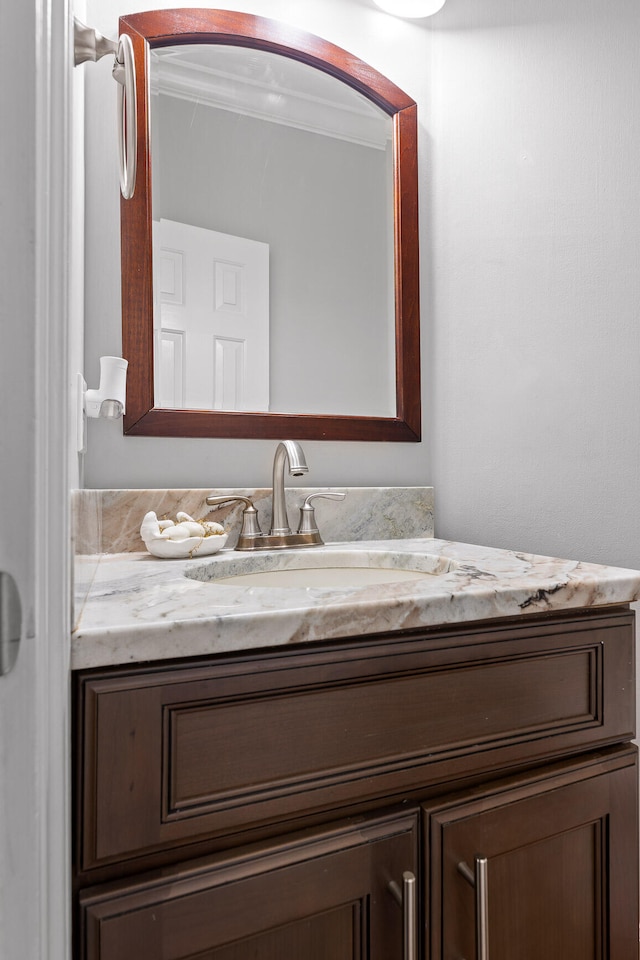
[74,608,638,960]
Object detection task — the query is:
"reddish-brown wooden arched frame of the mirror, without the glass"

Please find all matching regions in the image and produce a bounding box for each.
[120,8,421,442]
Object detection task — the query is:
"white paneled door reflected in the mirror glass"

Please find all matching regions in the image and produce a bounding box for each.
[153,219,269,412]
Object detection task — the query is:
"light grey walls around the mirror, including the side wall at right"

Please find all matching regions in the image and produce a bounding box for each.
[86,0,640,566]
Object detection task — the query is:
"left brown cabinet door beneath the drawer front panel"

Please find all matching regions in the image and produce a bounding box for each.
[79,812,418,960]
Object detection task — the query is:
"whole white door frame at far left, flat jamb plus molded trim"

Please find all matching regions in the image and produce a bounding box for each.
[0,0,72,960]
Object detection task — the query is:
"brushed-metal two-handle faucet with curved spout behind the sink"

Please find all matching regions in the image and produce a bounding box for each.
[207,440,346,550]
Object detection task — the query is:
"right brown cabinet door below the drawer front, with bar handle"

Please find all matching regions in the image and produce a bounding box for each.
[425,748,638,960]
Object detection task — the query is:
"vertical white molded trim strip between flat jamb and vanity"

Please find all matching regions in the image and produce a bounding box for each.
[34,0,72,960]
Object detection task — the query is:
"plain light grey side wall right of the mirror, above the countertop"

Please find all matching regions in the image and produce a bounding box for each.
[421,0,640,566]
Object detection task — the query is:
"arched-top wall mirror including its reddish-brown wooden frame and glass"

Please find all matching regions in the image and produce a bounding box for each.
[120,9,420,441]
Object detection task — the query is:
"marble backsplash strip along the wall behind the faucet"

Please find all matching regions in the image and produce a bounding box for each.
[72,487,434,555]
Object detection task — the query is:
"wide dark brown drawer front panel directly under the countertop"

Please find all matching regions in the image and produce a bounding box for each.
[81,613,634,869]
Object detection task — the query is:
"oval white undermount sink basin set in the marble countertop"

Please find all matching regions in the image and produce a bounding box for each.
[185,548,456,589]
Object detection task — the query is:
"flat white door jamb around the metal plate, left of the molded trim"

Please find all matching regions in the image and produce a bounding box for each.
[0,4,42,958]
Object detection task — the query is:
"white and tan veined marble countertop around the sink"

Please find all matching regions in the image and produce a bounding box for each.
[71,539,640,670]
